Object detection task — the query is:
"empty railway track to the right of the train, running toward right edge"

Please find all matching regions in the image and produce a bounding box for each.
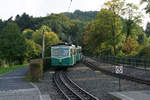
[83,60,150,85]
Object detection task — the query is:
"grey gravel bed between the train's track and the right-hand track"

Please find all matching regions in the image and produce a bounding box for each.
[67,64,150,100]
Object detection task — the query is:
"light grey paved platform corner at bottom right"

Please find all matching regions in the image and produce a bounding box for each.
[109,90,150,100]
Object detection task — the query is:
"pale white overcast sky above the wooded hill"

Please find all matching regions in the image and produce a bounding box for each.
[0,0,150,27]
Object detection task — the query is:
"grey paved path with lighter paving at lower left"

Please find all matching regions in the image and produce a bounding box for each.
[0,67,47,100]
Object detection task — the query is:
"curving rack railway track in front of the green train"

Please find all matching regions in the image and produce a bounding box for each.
[54,71,100,100]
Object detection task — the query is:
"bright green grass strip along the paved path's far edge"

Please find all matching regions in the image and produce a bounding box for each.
[0,64,29,75]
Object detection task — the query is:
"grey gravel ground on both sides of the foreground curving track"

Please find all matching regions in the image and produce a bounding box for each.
[34,63,150,100]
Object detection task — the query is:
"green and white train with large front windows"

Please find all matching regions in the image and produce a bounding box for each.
[51,43,82,67]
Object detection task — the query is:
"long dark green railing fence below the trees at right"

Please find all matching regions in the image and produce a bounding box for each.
[90,55,150,69]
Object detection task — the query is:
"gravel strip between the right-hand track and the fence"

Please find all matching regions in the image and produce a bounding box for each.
[87,58,150,80]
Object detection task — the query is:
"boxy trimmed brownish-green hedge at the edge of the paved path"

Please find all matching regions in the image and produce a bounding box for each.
[30,59,43,82]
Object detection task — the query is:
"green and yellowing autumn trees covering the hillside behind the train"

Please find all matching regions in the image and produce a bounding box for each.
[0,0,150,67]
